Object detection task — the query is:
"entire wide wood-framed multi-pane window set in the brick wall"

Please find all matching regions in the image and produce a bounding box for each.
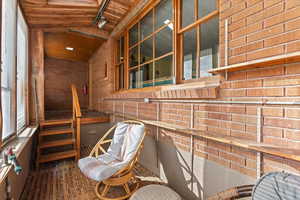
[116,0,219,89]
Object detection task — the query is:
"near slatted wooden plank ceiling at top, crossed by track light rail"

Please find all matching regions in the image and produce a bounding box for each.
[20,0,139,33]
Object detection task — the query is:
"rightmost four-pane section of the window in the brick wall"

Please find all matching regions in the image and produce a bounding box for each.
[179,0,219,80]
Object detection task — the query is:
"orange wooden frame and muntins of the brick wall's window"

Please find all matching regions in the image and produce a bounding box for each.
[115,0,220,91]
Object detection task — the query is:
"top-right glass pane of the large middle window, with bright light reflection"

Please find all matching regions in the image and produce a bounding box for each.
[155,0,173,30]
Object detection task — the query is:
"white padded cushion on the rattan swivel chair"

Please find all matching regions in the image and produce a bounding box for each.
[78,123,144,181]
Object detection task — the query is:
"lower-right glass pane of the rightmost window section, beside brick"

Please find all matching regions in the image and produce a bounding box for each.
[200,17,219,77]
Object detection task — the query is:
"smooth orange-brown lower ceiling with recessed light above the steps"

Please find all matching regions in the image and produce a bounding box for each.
[44,32,105,62]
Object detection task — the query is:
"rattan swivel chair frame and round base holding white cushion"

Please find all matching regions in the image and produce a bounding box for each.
[79,120,145,200]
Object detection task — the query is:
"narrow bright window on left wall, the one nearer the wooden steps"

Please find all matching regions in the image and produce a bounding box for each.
[17,8,28,132]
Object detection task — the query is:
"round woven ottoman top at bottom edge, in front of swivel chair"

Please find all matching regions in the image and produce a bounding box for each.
[130,185,181,200]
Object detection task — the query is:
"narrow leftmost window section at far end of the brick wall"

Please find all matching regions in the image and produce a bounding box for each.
[115,36,125,90]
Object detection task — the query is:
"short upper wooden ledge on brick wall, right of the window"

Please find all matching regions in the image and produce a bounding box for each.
[209,51,300,74]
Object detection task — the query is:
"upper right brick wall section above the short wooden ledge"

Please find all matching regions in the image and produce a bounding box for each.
[220,0,300,66]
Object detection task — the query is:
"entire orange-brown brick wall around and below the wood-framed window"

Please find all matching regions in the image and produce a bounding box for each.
[88,0,300,177]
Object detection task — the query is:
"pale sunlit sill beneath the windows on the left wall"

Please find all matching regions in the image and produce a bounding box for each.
[0,126,37,184]
